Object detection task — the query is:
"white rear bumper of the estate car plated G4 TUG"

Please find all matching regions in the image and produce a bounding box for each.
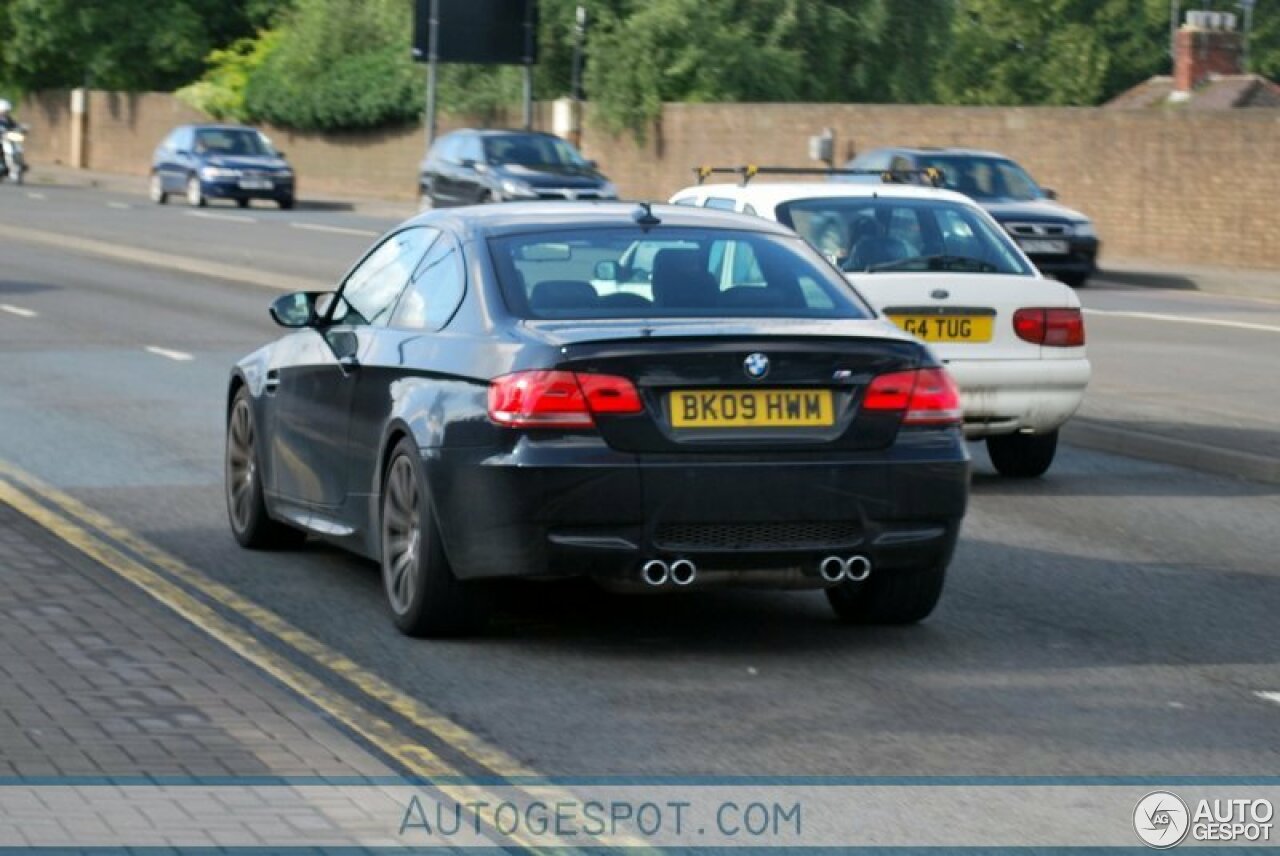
[947,358,1092,439]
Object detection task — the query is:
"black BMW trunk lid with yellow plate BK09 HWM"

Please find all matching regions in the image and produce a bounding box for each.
[525,319,928,456]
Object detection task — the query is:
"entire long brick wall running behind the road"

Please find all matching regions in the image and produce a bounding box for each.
[22,92,1280,269]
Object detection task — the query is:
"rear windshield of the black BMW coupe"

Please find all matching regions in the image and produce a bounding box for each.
[489,226,873,319]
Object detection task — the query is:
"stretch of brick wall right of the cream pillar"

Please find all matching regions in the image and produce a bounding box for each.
[582,104,1280,269]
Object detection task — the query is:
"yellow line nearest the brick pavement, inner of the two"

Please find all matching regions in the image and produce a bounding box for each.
[0,470,624,852]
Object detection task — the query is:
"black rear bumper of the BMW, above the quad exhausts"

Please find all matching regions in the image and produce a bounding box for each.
[424,431,969,585]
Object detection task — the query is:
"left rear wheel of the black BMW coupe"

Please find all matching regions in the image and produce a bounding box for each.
[379,439,489,638]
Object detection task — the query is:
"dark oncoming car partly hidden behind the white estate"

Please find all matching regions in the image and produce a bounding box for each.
[845,148,1100,288]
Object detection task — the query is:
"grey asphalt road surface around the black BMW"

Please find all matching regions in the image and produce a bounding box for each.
[0,188,1280,775]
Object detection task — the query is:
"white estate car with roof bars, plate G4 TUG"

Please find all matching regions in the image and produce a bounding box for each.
[671,182,1091,477]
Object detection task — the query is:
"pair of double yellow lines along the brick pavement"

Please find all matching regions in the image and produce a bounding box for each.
[0,459,648,856]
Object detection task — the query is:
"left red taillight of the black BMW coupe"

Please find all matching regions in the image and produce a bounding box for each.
[489,371,644,429]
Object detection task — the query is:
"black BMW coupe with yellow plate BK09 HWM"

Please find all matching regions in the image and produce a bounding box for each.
[225,203,969,636]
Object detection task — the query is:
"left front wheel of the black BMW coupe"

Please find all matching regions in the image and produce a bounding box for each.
[224,389,307,550]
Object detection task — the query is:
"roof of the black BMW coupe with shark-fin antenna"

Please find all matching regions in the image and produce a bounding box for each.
[408,201,795,237]
